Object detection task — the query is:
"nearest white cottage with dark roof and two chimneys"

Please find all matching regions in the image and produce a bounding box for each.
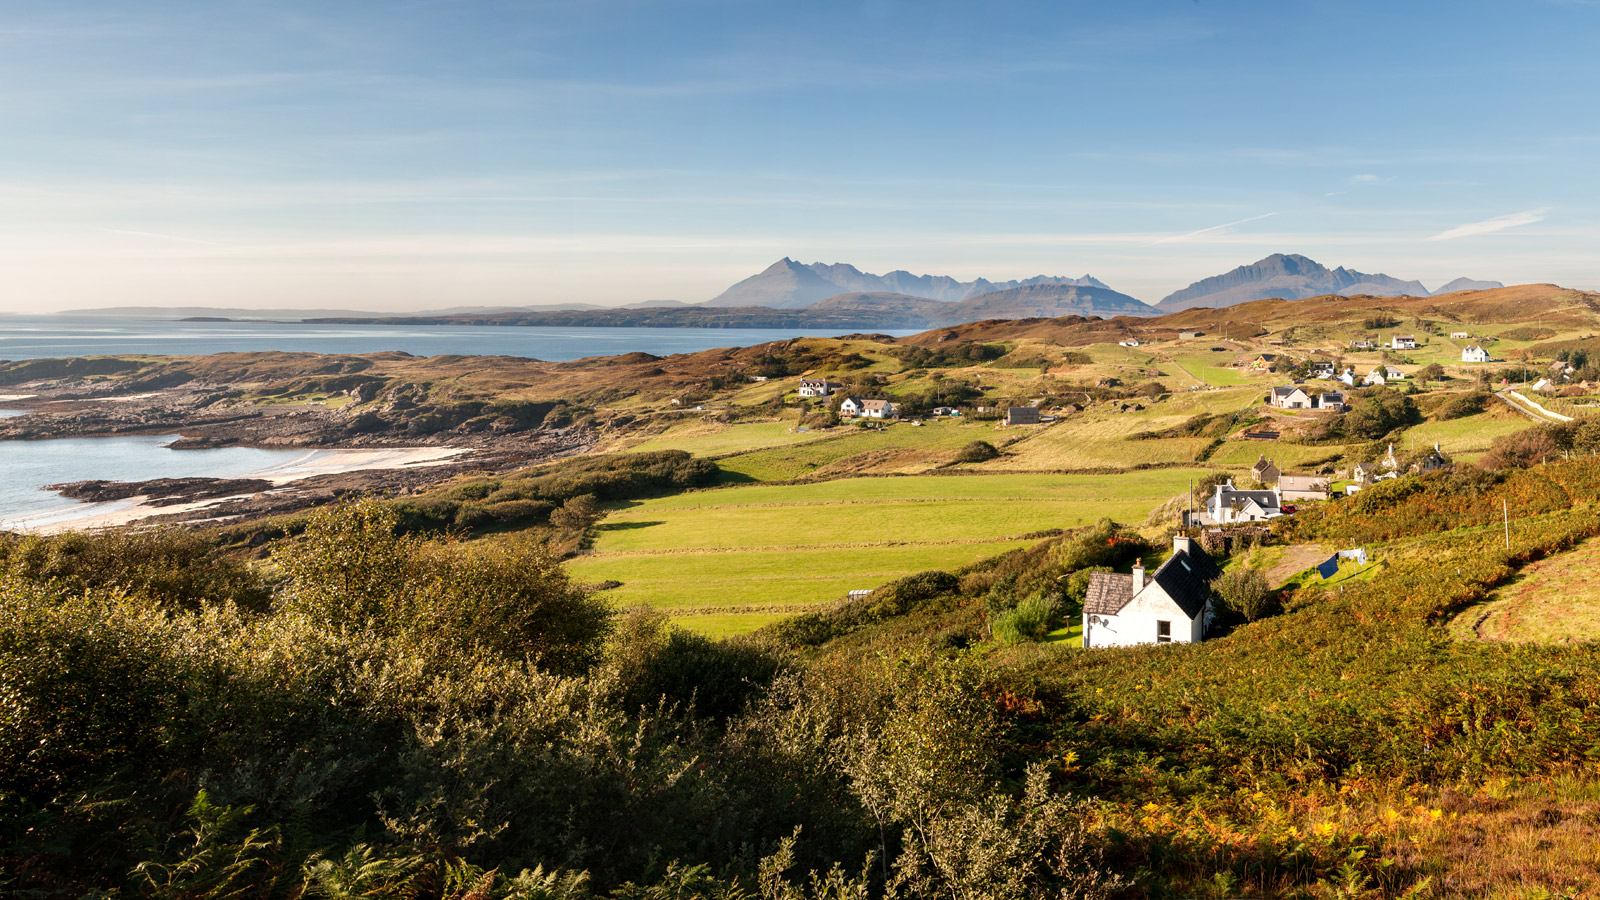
[1083,535,1221,647]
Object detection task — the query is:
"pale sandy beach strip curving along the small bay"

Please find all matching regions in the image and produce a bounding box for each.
[6,447,469,535]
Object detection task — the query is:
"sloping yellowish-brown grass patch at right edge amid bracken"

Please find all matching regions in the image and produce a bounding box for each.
[1450,540,1600,644]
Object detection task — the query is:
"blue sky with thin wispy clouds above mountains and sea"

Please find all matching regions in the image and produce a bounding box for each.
[0,0,1600,312]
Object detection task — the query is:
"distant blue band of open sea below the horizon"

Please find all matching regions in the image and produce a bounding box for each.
[0,315,914,360]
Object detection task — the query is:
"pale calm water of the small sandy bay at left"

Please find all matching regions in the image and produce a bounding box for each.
[0,434,329,528]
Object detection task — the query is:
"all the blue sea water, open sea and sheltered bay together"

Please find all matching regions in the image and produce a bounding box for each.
[0,315,914,530]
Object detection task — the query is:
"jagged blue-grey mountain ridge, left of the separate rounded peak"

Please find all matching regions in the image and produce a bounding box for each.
[706,256,1138,309]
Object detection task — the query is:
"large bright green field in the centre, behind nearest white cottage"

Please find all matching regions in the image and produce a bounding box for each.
[570,469,1197,634]
